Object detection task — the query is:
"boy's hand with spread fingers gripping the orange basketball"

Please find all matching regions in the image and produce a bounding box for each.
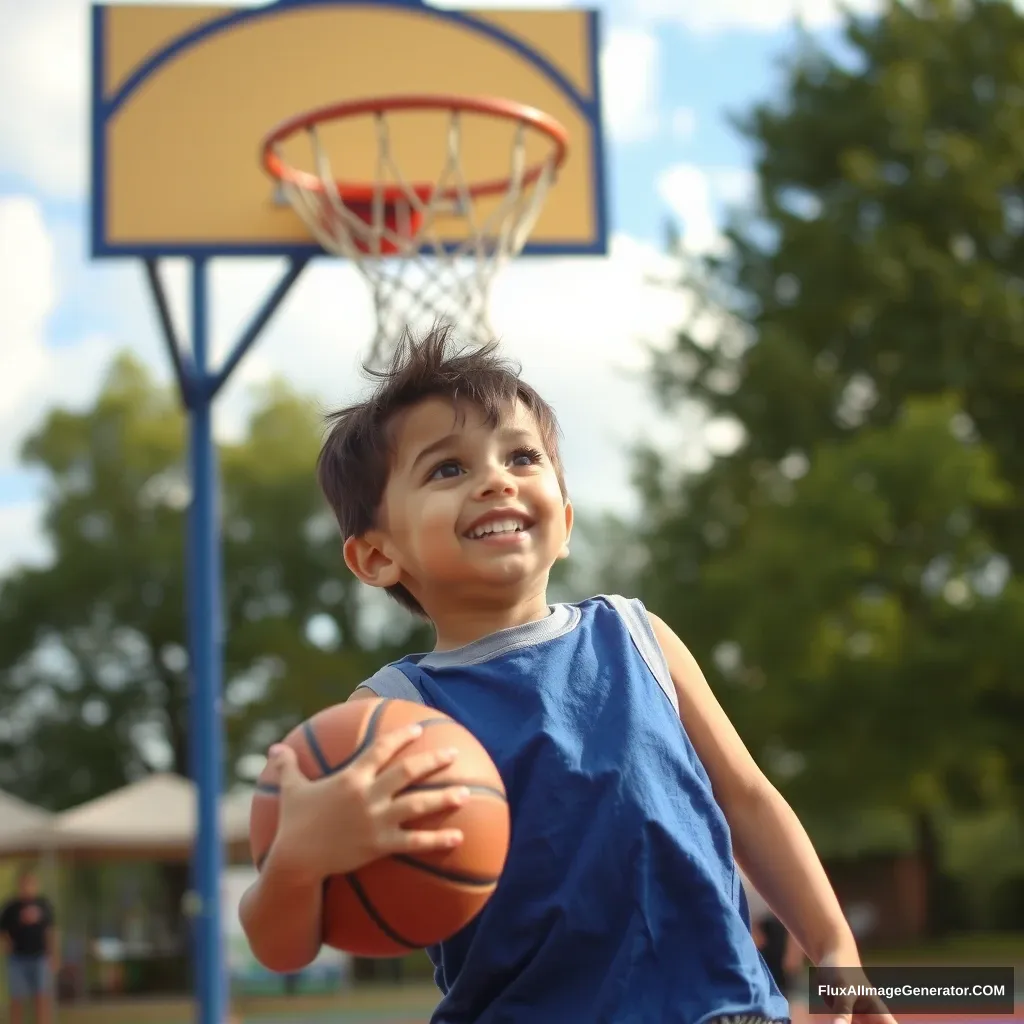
[267,725,469,885]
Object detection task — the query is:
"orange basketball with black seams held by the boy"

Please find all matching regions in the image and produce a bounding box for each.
[249,699,510,956]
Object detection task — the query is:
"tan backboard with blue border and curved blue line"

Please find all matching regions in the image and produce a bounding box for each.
[92,0,607,257]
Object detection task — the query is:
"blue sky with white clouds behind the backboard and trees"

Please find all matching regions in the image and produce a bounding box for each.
[0,0,873,572]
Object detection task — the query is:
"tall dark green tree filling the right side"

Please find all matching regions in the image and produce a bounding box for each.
[638,0,1024,921]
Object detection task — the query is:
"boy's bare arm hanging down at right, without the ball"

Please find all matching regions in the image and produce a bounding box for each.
[650,614,860,967]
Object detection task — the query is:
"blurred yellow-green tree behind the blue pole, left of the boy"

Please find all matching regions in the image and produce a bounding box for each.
[0,356,425,809]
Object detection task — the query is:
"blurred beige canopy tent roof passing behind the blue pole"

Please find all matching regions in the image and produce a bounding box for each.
[0,773,252,860]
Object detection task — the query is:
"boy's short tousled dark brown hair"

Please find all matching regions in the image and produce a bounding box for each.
[316,325,565,615]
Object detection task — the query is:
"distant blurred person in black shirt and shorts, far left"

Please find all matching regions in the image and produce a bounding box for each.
[0,868,56,1024]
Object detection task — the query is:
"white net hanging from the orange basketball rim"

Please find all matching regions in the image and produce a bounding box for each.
[272,103,557,366]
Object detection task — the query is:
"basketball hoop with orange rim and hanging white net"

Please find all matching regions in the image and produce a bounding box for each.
[262,95,568,364]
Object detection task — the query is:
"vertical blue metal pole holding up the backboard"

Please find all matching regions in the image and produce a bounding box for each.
[188,258,228,1024]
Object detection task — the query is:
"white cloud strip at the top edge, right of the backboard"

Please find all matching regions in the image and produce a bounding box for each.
[631,0,883,34]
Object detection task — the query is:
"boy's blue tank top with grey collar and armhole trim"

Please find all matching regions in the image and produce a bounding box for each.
[362,596,788,1024]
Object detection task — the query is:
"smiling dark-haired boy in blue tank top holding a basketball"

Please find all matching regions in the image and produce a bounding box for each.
[241,328,888,1024]
